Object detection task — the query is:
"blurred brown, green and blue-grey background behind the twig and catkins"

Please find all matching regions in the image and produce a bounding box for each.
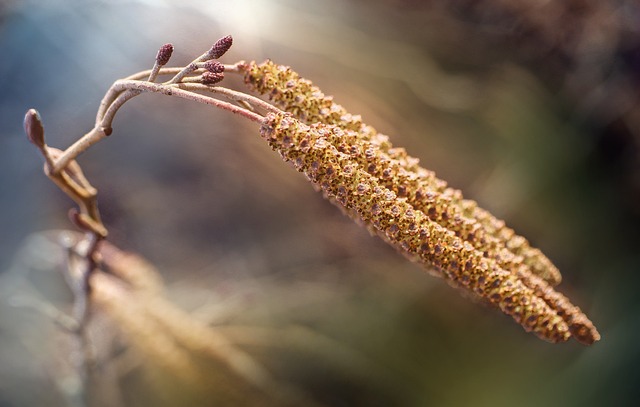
[0,0,640,407]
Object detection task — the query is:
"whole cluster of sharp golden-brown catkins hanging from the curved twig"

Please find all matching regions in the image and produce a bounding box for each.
[245,61,599,344]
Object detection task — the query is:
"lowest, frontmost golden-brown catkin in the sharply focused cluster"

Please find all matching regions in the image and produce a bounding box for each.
[260,114,571,342]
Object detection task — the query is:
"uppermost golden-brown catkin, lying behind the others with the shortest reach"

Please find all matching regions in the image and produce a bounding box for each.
[244,61,561,285]
